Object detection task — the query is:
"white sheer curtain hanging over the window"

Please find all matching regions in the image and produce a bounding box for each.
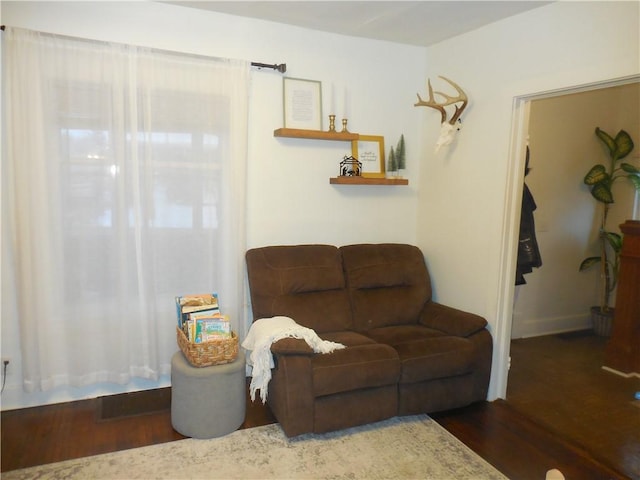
[2,28,250,391]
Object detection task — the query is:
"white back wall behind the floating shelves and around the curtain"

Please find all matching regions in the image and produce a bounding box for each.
[1,2,426,409]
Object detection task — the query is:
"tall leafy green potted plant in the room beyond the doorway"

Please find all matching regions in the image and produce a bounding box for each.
[580,127,640,336]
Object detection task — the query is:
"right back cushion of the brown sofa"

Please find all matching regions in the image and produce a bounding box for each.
[340,243,431,332]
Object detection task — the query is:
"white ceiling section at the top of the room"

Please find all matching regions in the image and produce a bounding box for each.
[166,0,552,47]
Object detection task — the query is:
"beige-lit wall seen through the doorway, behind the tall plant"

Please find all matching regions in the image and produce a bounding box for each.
[511,83,640,338]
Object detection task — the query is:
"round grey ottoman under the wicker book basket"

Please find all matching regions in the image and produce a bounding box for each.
[171,350,246,438]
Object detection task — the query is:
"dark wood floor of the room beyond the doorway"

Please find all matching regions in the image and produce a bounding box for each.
[507,331,640,478]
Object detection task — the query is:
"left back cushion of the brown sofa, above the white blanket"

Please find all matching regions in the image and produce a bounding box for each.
[246,245,352,333]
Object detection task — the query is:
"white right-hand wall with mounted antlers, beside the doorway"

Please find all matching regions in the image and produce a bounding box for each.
[418,2,640,398]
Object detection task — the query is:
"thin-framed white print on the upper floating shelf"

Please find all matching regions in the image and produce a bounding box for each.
[283,77,322,130]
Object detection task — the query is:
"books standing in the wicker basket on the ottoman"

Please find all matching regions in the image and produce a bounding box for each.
[176,293,231,343]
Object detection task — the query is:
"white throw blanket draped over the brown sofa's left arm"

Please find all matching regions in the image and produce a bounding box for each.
[242,316,345,403]
